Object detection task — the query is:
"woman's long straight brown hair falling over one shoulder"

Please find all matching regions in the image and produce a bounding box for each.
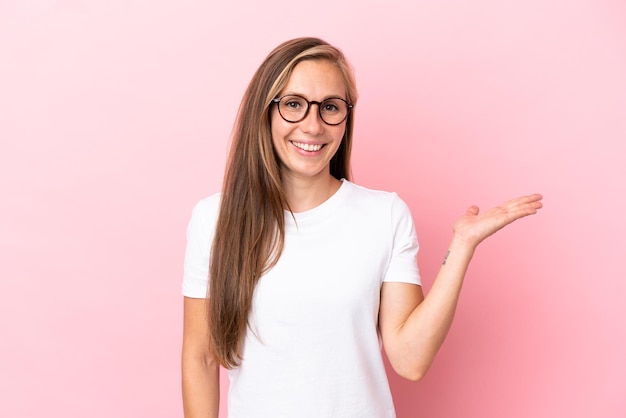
[208,38,357,368]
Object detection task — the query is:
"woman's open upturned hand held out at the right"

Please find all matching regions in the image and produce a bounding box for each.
[454,194,543,247]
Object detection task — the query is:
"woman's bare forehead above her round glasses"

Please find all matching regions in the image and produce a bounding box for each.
[281,60,346,100]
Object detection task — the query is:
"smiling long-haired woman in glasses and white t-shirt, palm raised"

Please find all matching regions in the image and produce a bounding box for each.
[182,38,541,418]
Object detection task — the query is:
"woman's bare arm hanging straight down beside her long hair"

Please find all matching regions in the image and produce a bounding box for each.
[182,297,220,418]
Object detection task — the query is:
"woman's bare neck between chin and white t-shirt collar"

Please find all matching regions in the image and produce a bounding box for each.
[283,173,341,213]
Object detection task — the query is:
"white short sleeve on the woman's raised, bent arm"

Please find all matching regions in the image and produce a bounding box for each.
[383,194,422,285]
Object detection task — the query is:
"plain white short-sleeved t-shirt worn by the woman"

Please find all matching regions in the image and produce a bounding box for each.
[183,180,420,418]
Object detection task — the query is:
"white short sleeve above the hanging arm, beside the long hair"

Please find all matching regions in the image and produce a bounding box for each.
[182,194,219,298]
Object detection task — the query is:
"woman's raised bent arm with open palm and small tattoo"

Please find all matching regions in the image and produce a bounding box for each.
[379,195,542,381]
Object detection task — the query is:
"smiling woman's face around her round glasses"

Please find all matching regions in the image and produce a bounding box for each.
[271,60,346,184]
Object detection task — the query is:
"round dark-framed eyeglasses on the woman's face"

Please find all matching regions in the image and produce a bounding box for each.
[272,94,354,126]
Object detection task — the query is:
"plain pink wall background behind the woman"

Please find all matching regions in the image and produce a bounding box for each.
[0,0,626,418]
